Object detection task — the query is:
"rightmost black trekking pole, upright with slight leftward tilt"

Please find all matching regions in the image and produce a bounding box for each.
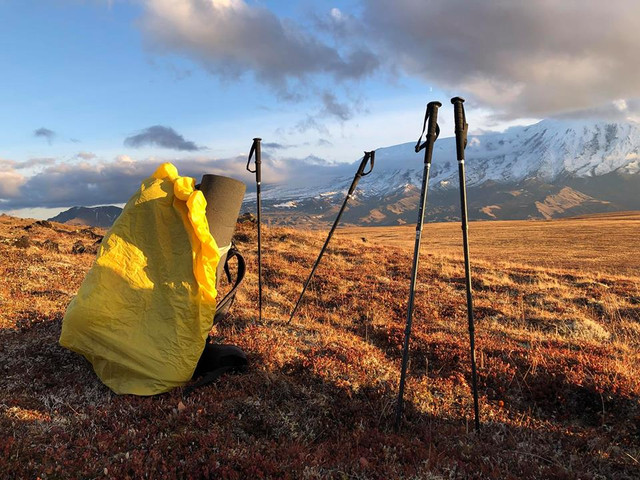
[451,97,480,431]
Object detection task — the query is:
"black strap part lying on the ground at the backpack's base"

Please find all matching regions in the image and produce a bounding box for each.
[182,343,247,398]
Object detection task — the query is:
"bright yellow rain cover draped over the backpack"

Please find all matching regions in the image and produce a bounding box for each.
[60,163,220,395]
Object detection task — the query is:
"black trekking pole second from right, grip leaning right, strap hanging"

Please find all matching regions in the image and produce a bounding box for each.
[395,102,442,430]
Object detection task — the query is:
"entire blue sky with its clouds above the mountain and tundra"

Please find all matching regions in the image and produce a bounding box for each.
[0,0,640,217]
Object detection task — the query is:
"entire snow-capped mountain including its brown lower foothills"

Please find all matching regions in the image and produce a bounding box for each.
[247,120,640,225]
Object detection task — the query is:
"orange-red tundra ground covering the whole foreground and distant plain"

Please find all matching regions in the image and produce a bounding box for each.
[0,213,640,479]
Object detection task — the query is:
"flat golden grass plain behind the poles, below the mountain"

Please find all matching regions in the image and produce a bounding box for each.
[337,212,640,275]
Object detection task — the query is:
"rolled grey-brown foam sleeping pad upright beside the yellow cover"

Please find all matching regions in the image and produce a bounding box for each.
[200,175,247,284]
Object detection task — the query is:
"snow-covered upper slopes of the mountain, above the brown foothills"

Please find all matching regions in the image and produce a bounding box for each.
[265,120,640,199]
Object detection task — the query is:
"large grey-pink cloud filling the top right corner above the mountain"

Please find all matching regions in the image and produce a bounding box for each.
[361,0,640,118]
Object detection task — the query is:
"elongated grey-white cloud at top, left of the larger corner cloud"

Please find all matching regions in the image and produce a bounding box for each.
[141,0,378,97]
